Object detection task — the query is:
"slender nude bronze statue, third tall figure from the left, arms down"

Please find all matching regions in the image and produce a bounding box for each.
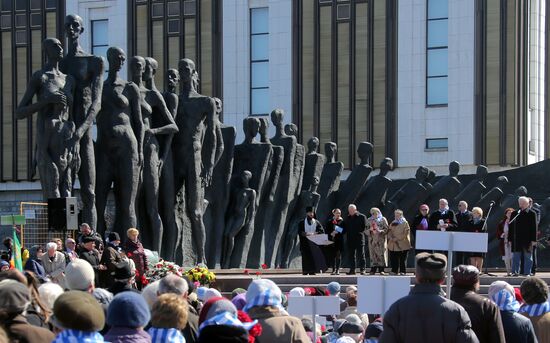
[96,47,145,235]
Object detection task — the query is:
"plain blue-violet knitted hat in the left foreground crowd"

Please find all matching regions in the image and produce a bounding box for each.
[107,292,151,328]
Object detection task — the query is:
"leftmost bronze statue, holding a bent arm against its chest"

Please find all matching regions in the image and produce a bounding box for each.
[16,38,76,199]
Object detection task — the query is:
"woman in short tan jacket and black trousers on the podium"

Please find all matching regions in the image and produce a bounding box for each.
[388,210,411,275]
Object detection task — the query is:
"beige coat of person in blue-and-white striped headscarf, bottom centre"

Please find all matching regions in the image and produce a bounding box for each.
[248,306,311,343]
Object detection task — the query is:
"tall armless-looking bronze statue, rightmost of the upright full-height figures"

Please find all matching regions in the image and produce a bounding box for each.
[172,58,216,263]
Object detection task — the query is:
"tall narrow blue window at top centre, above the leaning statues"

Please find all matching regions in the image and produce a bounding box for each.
[250,7,270,115]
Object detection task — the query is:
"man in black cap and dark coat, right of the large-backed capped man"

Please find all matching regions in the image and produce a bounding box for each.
[451,265,506,343]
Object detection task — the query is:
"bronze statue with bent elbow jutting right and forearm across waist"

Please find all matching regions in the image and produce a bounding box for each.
[138,57,178,251]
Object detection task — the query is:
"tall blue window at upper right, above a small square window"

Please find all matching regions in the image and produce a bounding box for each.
[426,0,449,106]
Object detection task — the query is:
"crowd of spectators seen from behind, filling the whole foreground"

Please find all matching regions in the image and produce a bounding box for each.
[0,247,550,343]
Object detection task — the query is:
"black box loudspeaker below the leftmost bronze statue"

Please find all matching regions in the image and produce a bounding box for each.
[48,198,78,231]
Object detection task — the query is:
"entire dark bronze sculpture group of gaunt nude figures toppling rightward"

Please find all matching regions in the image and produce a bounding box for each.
[16,15,550,268]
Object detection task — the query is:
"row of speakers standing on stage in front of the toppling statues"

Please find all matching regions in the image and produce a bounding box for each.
[299,197,540,275]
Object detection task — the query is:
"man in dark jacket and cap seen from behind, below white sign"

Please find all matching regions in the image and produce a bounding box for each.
[380,253,479,343]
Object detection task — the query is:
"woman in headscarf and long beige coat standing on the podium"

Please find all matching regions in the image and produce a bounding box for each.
[366,207,388,275]
